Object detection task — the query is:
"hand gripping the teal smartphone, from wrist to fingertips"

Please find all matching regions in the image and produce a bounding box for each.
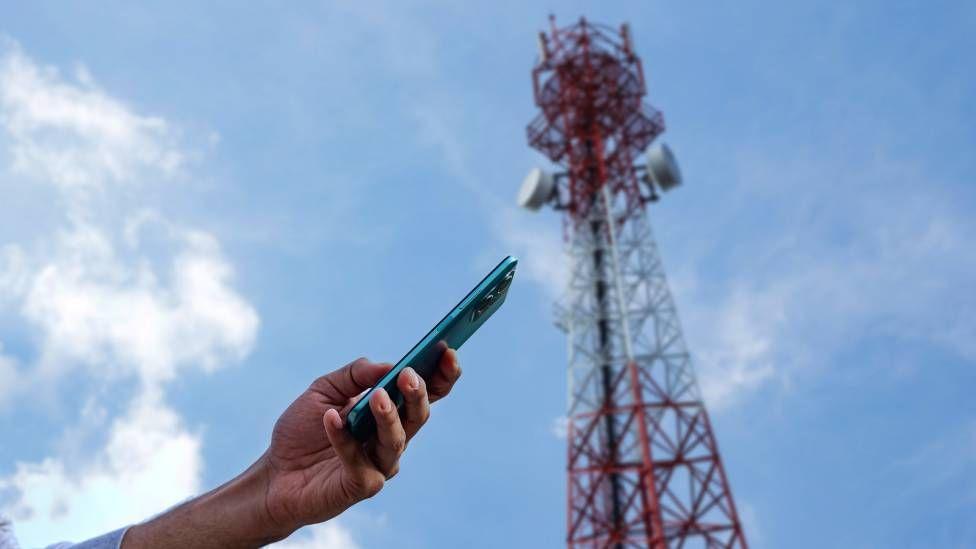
[256,349,461,535]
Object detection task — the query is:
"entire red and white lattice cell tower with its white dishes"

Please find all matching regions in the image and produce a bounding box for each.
[518,17,747,548]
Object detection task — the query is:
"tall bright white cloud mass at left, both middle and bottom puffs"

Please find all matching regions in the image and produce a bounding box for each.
[0,215,258,545]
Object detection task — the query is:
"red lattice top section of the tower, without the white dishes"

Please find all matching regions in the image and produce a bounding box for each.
[527,17,664,221]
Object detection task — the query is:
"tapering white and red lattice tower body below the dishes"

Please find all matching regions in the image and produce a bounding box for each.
[562,201,747,548]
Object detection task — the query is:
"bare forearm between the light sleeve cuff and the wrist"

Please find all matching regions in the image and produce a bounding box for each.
[122,458,291,549]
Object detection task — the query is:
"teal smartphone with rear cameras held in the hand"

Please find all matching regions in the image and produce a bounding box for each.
[346,256,518,441]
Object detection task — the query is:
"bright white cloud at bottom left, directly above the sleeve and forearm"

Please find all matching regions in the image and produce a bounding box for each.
[0,392,203,547]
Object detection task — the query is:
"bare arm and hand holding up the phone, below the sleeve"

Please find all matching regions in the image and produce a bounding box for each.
[121,350,461,549]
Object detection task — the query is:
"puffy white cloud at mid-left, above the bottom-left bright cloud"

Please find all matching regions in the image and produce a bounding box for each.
[23,218,258,383]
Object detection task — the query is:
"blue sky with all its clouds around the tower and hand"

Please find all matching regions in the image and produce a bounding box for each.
[0,2,976,548]
